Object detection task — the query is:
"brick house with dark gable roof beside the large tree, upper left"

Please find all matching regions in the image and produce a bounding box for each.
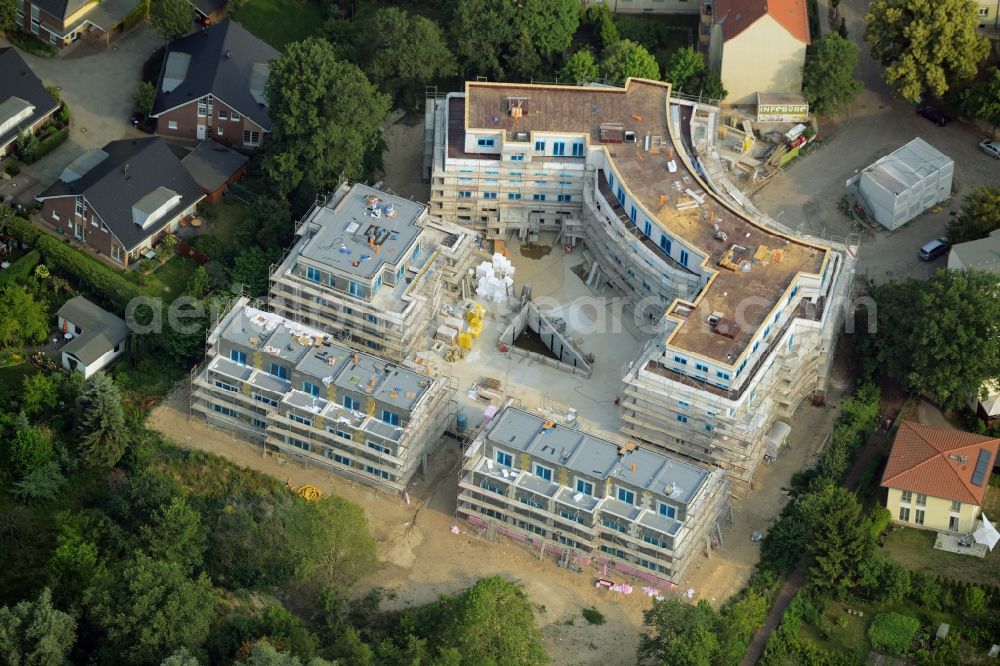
[150,20,280,147]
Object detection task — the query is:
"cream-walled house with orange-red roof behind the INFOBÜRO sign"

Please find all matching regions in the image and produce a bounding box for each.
[700,0,809,104]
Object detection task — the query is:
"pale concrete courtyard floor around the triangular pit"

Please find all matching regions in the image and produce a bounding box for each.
[441,234,649,437]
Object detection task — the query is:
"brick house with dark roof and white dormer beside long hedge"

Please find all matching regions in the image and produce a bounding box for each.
[36,137,205,266]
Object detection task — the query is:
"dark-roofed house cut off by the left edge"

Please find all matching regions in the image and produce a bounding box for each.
[0,47,59,157]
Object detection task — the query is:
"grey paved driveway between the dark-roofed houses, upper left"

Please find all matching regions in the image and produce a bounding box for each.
[0,24,164,190]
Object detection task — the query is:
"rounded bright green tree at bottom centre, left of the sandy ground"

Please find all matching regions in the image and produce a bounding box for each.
[431,576,549,666]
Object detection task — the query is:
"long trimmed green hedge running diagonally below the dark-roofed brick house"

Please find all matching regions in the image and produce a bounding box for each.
[8,216,143,313]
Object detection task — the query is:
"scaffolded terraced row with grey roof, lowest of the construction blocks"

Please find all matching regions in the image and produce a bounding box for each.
[458,405,729,585]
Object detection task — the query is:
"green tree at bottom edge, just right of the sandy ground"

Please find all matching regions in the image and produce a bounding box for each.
[639,599,721,666]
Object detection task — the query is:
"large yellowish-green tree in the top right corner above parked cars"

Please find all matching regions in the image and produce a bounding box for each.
[865,0,989,103]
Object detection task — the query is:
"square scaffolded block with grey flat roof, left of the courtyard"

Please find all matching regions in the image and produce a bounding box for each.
[268,184,476,361]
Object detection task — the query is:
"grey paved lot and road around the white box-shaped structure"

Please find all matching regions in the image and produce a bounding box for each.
[754,0,1000,282]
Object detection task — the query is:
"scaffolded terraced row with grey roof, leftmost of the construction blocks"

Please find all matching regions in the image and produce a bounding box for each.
[191,298,454,493]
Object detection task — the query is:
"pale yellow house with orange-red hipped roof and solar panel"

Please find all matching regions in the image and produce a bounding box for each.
[882,421,1000,533]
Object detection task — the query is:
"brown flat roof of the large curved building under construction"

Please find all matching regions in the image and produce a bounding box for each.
[448,79,828,366]
